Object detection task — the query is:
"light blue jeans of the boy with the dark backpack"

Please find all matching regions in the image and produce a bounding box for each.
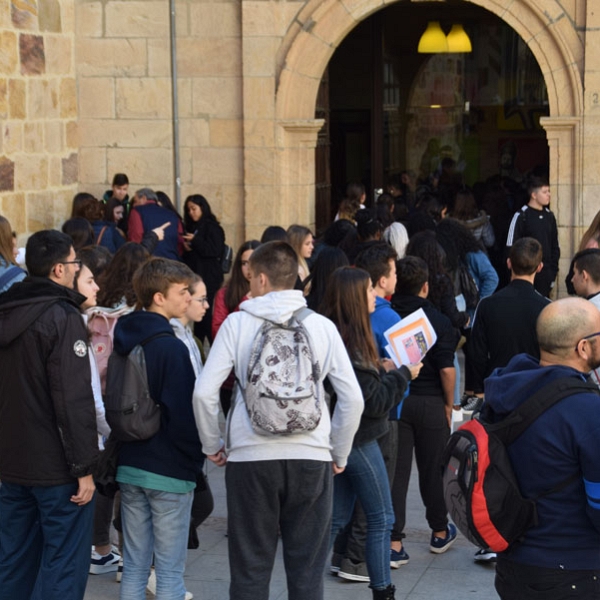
[119,483,193,600]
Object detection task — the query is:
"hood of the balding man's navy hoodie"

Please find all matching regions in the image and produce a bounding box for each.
[485,354,587,420]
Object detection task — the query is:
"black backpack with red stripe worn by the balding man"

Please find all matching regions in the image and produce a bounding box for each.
[442,377,600,552]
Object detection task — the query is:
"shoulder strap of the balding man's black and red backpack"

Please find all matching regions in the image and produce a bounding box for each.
[487,377,600,446]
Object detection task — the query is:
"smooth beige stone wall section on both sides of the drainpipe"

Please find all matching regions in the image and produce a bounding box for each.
[75,0,244,245]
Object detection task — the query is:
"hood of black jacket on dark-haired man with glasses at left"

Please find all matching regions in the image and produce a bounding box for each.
[0,277,85,346]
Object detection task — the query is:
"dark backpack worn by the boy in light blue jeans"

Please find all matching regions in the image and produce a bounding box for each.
[104,333,170,442]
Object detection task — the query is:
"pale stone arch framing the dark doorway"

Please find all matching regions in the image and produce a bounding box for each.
[244,0,584,276]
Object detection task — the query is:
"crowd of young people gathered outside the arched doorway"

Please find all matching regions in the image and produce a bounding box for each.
[0,166,600,600]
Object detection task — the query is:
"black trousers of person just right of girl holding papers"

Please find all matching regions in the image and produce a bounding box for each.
[392,394,450,541]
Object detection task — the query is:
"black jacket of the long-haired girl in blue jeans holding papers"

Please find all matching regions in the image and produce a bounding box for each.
[327,363,411,446]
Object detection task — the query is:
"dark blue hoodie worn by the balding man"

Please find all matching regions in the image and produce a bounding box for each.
[484,354,600,570]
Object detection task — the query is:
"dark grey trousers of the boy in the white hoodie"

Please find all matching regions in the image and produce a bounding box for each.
[225,460,333,600]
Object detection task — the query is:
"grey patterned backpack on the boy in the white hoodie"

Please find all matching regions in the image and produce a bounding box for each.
[238,307,323,435]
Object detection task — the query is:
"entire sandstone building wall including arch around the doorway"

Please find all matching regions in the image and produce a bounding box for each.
[0,0,600,288]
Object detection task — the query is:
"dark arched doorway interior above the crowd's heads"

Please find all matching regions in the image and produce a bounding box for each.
[324,2,549,228]
